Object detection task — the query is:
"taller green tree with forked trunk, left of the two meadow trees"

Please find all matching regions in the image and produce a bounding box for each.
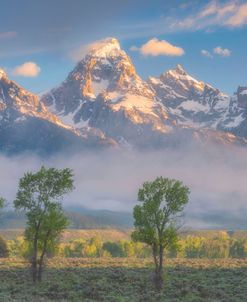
[14,167,73,282]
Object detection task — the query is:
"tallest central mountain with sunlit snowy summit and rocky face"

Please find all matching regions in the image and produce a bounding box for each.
[42,38,174,147]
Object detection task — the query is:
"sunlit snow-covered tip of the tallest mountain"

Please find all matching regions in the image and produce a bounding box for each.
[88,38,122,58]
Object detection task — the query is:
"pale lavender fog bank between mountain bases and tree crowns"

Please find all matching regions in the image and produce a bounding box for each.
[0,146,247,228]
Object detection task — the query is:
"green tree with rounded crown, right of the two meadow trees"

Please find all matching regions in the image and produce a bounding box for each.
[132,177,189,289]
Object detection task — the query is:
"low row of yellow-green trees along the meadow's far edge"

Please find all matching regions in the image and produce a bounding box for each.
[0,232,247,259]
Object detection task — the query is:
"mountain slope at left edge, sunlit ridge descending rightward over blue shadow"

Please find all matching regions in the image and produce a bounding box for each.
[0,69,114,156]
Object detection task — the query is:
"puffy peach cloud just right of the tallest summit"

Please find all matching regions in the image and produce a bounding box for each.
[135,38,185,56]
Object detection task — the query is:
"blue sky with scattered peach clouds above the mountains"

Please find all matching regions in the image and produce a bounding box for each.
[0,0,247,94]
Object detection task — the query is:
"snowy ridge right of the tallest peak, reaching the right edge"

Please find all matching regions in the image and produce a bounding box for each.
[148,65,247,138]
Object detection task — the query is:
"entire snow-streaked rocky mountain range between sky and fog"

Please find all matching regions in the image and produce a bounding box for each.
[0,38,247,155]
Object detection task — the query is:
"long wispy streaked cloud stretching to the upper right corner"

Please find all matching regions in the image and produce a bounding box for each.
[119,0,247,39]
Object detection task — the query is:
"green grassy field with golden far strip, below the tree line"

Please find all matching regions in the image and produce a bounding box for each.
[0,258,247,302]
